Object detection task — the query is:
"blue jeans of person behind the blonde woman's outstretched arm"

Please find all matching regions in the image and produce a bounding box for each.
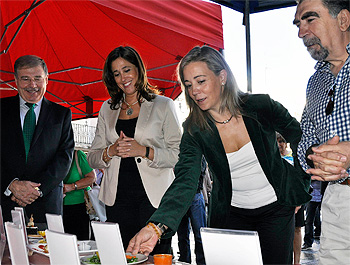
[177,192,207,265]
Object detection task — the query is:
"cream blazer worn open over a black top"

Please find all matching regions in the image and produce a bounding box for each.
[87,95,181,208]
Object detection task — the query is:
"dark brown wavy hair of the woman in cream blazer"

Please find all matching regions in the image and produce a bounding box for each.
[102,46,159,109]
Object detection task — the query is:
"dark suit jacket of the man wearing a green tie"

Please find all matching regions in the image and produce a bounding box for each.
[0,95,74,223]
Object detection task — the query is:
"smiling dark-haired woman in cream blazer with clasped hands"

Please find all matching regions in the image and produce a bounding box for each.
[88,46,181,253]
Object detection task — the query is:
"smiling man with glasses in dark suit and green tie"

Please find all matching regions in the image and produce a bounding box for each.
[0,55,74,228]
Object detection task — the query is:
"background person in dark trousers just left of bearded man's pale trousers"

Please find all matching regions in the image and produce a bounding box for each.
[302,180,322,250]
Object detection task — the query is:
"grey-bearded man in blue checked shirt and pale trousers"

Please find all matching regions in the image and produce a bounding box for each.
[294,0,350,265]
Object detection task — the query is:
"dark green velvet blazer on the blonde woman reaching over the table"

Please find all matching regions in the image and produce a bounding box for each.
[150,95,311,234]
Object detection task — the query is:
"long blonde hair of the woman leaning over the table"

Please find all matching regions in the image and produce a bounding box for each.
[177,45,244,133]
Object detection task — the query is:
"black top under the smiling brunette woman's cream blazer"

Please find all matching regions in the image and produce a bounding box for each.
[115,118,147,202]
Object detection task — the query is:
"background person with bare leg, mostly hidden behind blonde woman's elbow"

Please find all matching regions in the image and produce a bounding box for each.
[276,133,305,265]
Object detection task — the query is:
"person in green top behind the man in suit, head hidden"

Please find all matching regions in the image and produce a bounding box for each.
[63,150,96,240]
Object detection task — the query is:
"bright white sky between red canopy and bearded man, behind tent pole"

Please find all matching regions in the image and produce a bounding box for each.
[221,6,316,121]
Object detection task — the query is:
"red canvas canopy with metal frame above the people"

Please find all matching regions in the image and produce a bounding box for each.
[0,0,223,119]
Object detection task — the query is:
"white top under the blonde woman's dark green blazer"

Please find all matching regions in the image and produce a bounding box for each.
[226,142,277,209]
